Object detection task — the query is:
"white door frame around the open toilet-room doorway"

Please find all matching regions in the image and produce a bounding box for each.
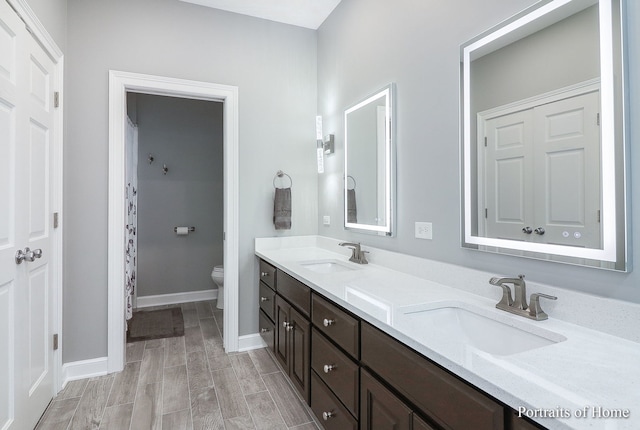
[107,70,239,373]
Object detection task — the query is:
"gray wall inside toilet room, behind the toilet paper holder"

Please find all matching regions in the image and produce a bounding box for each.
[136,94,224,297]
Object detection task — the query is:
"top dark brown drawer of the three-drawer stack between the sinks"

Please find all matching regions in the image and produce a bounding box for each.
[311,294,360,360]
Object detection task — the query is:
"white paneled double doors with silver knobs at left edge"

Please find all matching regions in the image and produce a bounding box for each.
[0,1,55,430]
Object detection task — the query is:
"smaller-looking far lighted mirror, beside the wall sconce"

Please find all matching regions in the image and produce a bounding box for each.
[344,84,394,236]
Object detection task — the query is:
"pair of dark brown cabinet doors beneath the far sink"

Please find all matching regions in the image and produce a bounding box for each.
[274,282,311,403]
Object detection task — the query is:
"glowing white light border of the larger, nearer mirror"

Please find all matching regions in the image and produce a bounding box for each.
[461,0,627,266]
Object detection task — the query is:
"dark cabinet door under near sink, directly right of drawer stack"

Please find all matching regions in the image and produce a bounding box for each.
[360,370,413,430]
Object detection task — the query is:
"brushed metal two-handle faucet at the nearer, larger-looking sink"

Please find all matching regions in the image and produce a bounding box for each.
[489,275,558,321]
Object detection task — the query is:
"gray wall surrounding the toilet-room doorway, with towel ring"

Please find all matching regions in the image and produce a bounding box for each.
[63,0,318,363]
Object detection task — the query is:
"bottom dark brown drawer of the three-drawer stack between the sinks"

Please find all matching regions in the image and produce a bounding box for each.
[311,372,358,430]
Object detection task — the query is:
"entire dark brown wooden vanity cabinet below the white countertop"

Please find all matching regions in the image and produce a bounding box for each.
[260,261,542,430]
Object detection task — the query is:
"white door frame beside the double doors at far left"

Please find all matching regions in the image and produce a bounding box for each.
[7,0,64,396]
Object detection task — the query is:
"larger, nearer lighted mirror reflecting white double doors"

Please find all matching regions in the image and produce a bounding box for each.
[461,0,630,270]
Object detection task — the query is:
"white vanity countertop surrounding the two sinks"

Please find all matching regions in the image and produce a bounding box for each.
[255,236,640,430]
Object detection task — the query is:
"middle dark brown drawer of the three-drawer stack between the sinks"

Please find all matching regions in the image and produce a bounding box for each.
[311,328,360,417]
